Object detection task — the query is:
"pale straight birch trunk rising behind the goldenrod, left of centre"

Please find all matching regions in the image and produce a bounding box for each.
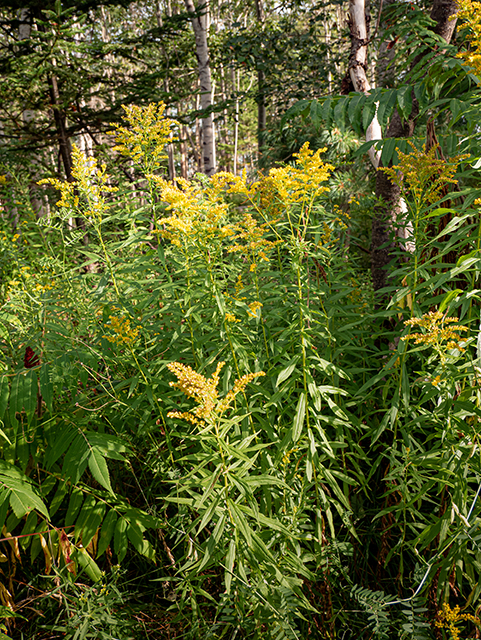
[185,0,216,176]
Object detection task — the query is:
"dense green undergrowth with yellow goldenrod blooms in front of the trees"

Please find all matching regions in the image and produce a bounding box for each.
[0,105,481,640]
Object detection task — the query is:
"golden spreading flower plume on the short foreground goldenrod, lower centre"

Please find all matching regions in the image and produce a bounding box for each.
[167,362,265,424]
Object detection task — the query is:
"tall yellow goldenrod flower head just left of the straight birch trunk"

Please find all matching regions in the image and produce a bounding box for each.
[109,102,177,173]
